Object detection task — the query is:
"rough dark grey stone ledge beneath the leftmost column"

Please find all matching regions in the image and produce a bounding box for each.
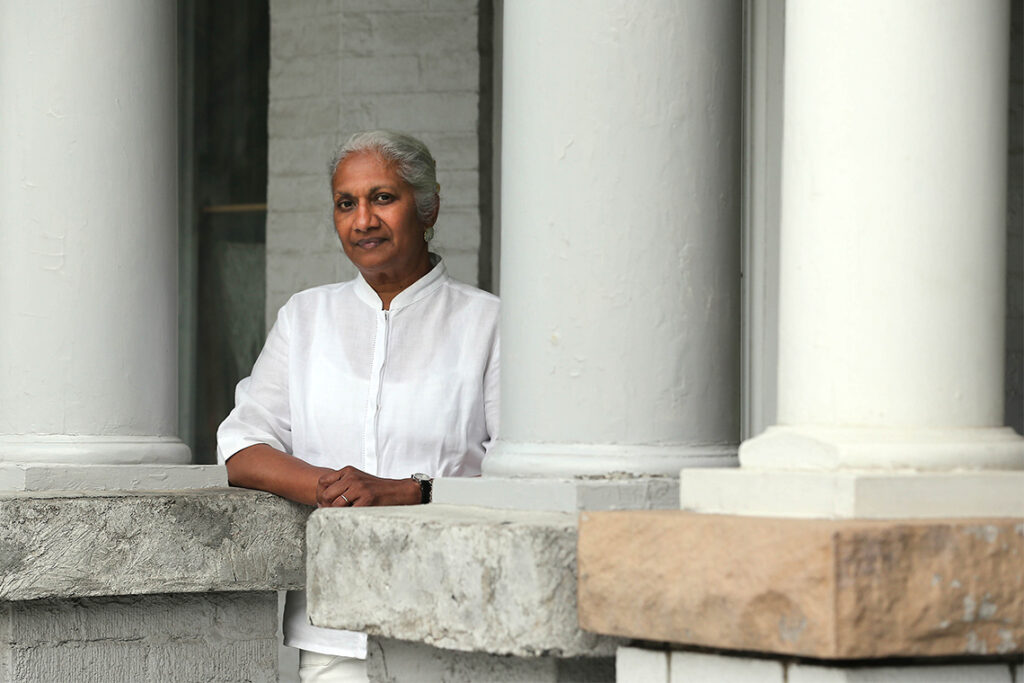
[0,488,310,600]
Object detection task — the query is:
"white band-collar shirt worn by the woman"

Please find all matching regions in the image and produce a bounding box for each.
[217,255,500,656]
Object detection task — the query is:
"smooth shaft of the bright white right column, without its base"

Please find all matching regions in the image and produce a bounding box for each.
[778,0,1009,436]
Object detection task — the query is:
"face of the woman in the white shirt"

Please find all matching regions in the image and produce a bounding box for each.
[332,152,433,280]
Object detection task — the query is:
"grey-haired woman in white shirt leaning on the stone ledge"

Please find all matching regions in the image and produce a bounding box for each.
[217,131,499,681]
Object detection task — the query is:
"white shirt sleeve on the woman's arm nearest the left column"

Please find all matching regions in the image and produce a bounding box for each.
[217,305,292,463]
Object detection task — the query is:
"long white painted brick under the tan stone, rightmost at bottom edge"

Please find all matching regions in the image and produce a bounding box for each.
[788,664,1011,683]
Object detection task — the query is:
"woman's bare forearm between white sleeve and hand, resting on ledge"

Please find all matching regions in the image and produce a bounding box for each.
[226,443,333,505]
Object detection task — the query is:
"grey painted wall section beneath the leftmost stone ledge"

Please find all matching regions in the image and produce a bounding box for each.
[0,592,278,683]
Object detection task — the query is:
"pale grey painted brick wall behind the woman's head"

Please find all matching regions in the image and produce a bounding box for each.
[266,0,490,325]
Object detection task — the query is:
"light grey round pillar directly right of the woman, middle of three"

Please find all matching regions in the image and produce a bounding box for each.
[483,0,741,476]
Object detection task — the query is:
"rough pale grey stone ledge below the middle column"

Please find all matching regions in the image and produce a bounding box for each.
[307,504,617,657]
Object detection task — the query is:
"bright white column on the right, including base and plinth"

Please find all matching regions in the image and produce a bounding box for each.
[683,0,1024,516]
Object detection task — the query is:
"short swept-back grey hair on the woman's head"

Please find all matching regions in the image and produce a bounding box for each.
[328,130,440,221]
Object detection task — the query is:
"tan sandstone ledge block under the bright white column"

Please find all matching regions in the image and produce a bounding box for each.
[579,511,1024,659]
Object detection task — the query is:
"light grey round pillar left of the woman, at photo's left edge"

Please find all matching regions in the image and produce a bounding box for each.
[0,0,189,464]
